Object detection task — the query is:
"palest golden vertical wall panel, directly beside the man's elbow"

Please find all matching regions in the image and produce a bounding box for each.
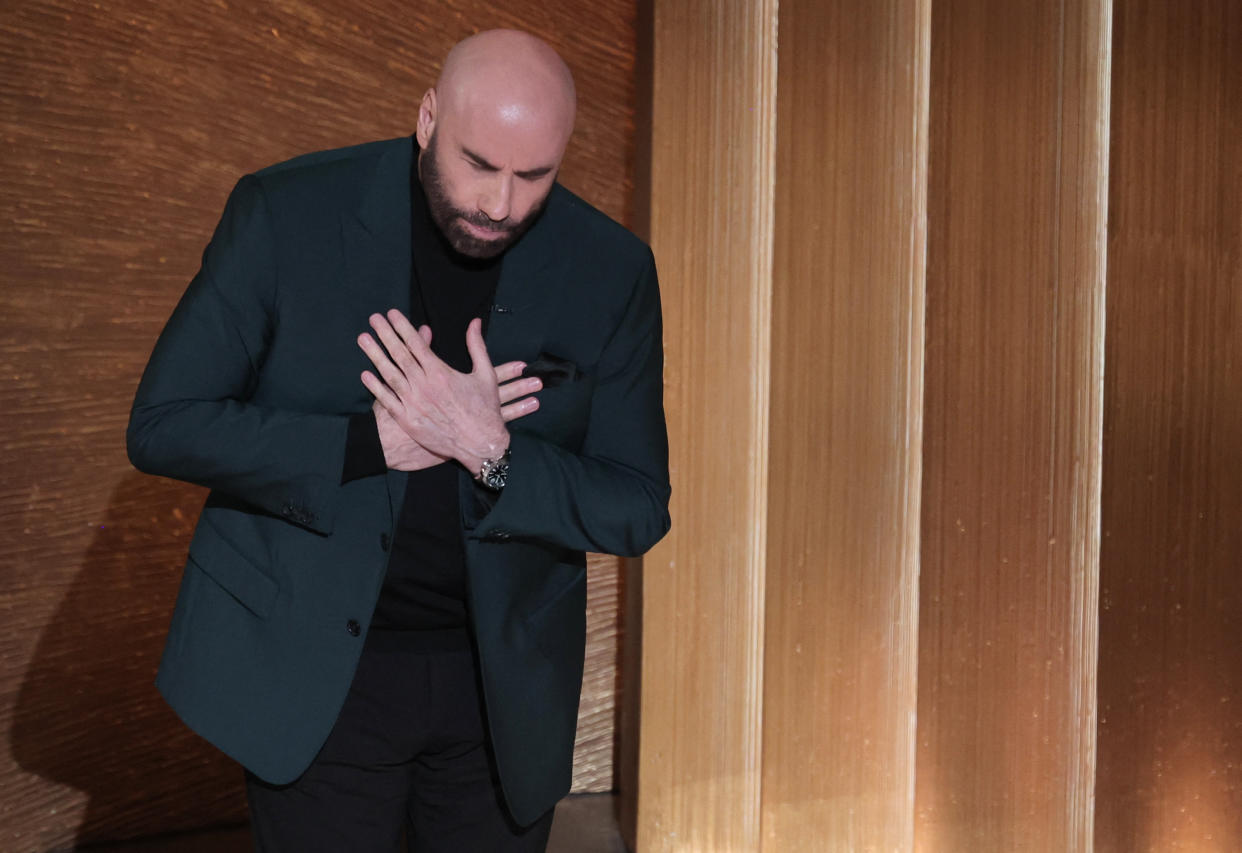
[637,0,776,853]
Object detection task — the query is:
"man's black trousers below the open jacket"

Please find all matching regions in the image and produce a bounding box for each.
[246,631,551,853]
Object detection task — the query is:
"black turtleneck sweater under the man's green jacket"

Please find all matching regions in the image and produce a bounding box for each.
[342,142,501,631]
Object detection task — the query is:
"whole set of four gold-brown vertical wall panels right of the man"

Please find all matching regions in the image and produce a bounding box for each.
[638,0,1242,853]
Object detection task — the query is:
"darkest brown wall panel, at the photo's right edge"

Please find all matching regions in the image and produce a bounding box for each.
[1095,0,1242,853]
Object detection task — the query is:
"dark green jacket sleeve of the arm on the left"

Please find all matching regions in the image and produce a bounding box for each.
[125,176,349,534]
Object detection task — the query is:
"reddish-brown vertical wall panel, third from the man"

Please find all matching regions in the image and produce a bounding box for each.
[915,0,1110,853]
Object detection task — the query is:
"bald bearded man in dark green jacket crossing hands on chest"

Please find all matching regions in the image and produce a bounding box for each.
[127,31,669,853]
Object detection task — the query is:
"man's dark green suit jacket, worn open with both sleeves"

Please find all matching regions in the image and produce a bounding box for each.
[128,138,669,823]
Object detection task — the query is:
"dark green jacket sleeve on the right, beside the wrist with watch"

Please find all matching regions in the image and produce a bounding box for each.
[468,253,669,556]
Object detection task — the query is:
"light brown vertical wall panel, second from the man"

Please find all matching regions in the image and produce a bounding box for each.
[763,0,932,853]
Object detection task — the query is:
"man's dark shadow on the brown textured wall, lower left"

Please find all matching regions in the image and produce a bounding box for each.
[11,472,246,844]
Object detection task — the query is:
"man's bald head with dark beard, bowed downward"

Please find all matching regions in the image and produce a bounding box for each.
[417,30,576,257]
